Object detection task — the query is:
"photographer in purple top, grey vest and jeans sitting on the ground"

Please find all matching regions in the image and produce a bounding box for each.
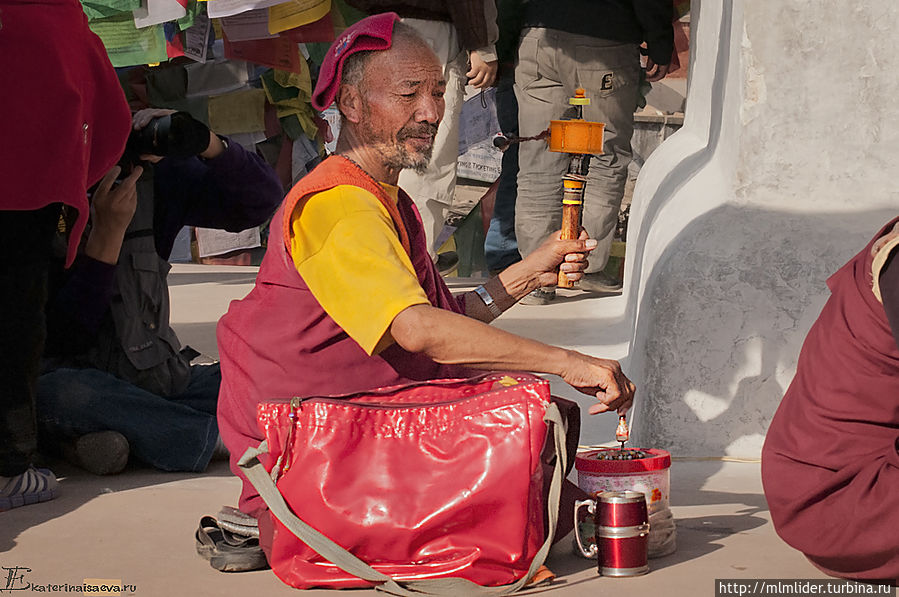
[37,109,283,474]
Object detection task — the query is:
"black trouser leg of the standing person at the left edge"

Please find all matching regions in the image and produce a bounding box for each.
[0,203,60,477]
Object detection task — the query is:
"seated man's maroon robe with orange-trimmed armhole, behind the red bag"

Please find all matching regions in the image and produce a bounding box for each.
[217,156,471,515]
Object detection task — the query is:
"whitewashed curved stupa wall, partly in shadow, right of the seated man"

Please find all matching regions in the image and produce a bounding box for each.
[625,0,899,458]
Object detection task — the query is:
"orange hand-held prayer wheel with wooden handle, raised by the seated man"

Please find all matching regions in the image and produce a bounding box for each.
[549,89,605,288]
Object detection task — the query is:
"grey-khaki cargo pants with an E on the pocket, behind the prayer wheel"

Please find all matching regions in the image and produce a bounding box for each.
[515,28,640,273]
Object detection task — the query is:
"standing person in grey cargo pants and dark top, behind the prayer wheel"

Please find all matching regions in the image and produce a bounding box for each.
[515,0,674,305]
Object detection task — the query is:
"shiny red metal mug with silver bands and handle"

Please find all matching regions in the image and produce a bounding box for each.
[574,491,649,576]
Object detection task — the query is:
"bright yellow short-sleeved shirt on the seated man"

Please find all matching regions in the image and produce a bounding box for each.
[290,183,428,354]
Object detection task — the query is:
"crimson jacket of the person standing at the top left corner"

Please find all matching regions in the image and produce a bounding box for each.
[0,0,131,264]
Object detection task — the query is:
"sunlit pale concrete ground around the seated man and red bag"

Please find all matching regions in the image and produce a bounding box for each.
[0,265,826,597]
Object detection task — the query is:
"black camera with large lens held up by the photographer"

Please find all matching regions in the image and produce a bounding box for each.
[121,112,209,171]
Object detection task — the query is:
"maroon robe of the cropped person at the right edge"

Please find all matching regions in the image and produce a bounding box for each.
[762,218,899,582]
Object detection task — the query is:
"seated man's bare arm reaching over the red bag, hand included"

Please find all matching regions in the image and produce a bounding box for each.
[390,305,634,414]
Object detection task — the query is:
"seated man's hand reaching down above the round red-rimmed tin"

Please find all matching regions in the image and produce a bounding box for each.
[561,350,636,415]
